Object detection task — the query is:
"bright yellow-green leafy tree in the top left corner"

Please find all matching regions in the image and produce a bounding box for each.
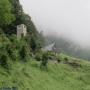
[0,0,15,27]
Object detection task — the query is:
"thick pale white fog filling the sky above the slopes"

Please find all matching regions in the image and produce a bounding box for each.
[20,0,90,45]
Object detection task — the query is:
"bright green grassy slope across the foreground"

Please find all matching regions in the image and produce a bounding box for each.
[0,55,90,90]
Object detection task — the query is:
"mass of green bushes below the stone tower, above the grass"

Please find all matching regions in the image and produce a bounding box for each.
[0,34,30,68]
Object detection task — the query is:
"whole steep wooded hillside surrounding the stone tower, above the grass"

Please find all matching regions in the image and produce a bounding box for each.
[0,0,43,69]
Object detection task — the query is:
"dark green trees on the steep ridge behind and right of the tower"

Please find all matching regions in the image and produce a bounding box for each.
[2,0,43,52]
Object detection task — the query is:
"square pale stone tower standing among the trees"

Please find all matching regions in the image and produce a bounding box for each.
[17,24,27,39]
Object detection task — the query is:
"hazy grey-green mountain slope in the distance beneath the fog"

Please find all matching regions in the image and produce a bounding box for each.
[46,35,90,60]
